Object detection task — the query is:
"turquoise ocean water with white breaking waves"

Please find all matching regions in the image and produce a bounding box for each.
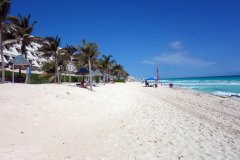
[158,76,240,100]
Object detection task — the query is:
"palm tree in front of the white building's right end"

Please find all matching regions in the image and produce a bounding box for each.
[38,36,66,83]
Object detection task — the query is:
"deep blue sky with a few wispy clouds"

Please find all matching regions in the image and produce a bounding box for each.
[10,0,240,79]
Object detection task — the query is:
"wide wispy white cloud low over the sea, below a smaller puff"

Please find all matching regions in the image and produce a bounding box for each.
[142,51,216,67]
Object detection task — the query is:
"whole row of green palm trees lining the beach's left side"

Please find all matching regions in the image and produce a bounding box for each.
[0,0,129,88]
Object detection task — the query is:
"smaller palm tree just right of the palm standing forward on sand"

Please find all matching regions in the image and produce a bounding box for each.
[99,55,116,85]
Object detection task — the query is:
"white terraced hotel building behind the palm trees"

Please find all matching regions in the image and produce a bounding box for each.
[0,43,53,74]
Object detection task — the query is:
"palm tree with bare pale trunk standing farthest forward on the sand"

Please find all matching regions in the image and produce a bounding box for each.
[74,39,100,90]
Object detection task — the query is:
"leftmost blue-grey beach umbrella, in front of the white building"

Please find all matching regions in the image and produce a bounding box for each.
[7,55,32,83]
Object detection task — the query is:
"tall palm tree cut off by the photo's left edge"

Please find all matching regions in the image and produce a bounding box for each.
[0,0,11,84]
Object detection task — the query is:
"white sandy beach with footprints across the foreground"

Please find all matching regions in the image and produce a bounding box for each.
[0,82,240,160]
